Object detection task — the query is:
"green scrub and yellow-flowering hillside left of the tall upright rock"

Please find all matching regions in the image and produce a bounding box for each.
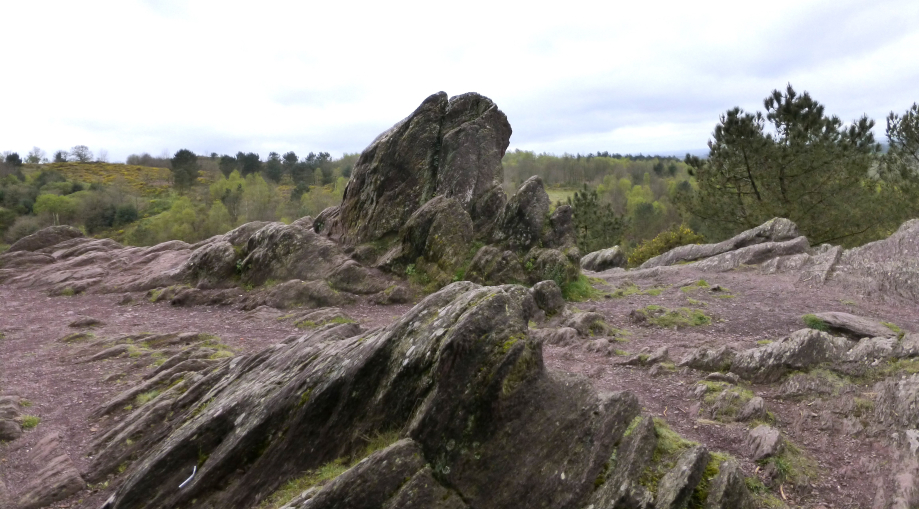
[0,146,357,245]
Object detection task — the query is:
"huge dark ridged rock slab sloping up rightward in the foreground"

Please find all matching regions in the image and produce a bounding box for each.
[102,282,639,509]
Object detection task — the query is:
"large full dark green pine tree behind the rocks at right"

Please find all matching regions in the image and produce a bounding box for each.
[680,85,886,245]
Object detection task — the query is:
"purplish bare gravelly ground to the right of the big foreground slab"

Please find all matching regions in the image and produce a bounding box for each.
[545,270,919,508]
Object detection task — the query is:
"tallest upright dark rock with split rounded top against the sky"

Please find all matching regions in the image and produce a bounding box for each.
[316,92,511,250]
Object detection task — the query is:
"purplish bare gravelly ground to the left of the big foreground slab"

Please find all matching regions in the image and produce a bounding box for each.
[0,286,410,507]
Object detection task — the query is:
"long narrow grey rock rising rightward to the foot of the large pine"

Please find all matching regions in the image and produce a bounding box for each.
[641,217,799,269]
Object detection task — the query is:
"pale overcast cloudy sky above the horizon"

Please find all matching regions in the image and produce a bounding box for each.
[0,0,919,161]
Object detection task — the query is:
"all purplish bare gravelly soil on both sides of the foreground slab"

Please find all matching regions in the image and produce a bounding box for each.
[0,270,919,508]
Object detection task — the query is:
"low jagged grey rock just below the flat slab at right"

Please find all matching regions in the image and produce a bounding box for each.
[731,329,852,383]
